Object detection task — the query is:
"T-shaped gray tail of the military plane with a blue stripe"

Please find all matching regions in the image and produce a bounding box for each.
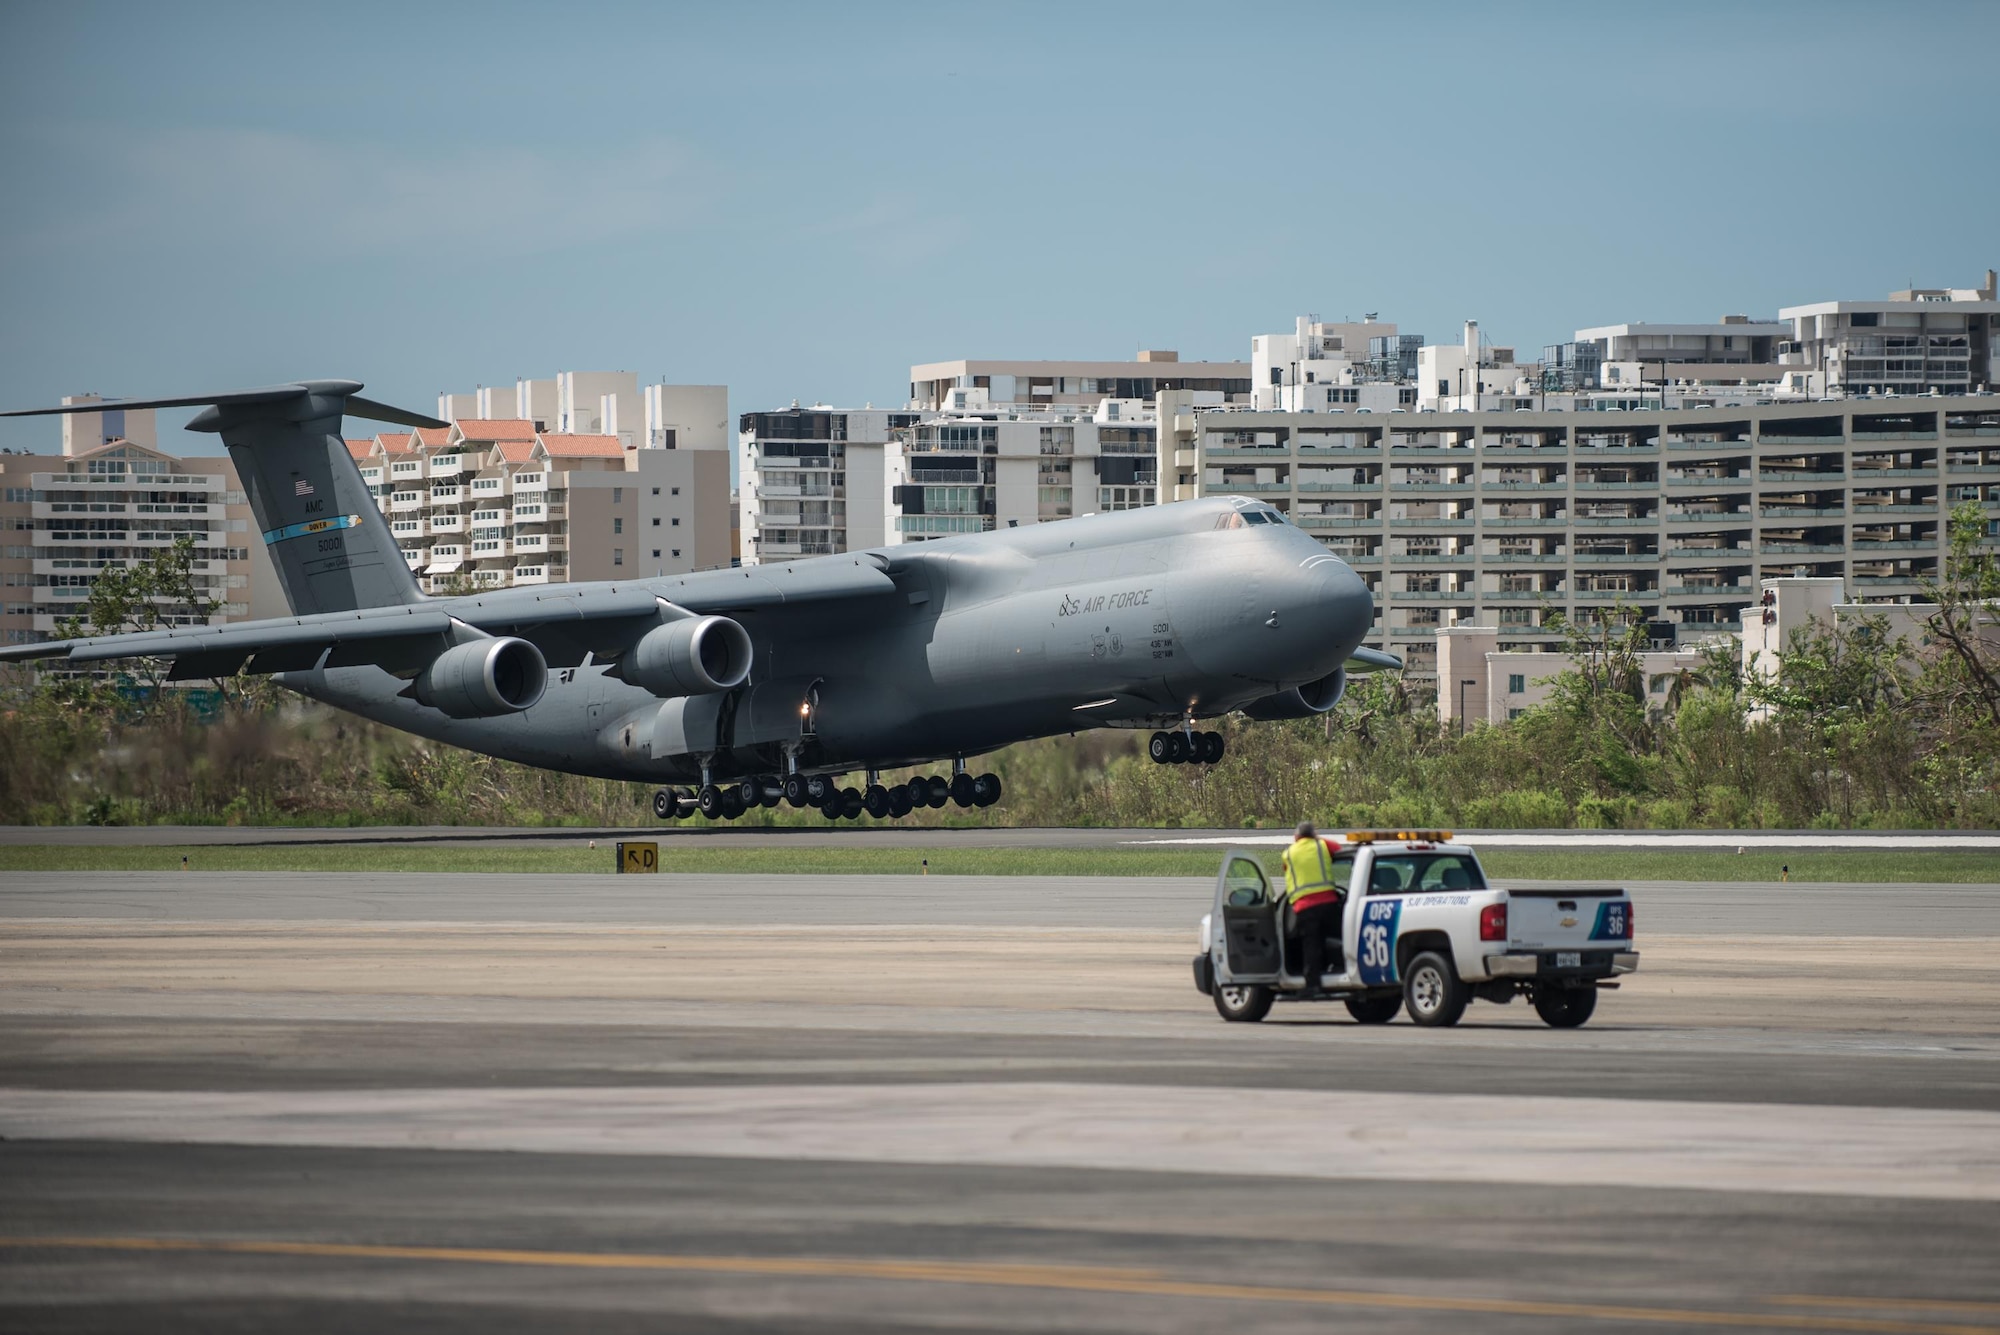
[0,380,444,616]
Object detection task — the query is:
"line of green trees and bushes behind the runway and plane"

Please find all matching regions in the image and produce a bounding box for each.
[0,506,2000,829]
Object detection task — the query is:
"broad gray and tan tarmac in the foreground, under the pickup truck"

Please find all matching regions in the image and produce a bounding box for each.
[0,873,2000,1333]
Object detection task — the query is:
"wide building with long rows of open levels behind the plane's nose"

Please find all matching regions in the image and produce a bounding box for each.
[1158,394,2000,677]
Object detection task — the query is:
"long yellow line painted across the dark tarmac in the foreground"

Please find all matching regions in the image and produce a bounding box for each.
[0,1237,2000,1335]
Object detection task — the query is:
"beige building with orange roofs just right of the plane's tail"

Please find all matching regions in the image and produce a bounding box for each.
[348,418,730,594]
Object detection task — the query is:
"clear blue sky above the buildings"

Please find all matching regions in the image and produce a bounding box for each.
[0,0,2000,450]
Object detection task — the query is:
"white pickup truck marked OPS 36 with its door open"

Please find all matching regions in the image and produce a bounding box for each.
[1194,829,1638,1029]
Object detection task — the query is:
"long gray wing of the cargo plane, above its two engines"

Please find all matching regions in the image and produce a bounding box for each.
[0,556,896,681]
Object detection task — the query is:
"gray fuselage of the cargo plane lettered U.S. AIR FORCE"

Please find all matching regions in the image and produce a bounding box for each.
[278,498,1374,783]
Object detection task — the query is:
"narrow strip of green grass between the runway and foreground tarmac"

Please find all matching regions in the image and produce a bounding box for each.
[0,839,2000,883]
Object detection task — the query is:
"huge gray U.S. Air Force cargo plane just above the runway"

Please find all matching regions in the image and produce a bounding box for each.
[0,380,1402,819]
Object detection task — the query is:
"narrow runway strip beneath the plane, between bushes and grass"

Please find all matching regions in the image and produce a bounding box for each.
[0,819,2000,851]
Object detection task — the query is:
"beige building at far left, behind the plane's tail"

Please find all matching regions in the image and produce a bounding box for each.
[0,398,286,644]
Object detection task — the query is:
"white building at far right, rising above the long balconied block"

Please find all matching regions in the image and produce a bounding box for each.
[1778,270,2000,396]
